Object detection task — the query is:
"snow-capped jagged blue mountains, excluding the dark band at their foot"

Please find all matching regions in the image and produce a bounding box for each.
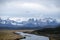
[0,18,58,28]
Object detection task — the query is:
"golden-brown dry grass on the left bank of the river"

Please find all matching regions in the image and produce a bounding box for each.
[0,30,32,40]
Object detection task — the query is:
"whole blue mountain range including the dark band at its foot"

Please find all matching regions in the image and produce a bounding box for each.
[0,17,60,29]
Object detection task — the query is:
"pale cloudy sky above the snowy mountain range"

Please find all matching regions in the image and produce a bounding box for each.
[0,0,60,19]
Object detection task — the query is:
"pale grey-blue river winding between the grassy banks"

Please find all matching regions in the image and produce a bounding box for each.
[17,32,49,40]
